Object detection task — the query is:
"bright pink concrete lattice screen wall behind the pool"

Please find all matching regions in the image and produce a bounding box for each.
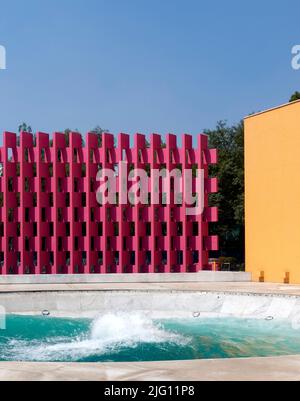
[0,132,218,275]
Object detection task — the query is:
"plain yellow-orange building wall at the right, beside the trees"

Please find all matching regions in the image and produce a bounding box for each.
[245,101,300,284]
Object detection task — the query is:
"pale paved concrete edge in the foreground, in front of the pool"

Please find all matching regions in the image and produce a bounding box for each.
[0,356,300,381]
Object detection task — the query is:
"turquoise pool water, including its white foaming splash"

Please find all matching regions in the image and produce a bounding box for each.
[0,313,300,362]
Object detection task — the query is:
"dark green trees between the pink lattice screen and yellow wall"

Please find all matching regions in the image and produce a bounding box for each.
[205,121,245,261]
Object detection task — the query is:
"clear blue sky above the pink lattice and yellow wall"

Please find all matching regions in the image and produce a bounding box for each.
[0,0,300,141]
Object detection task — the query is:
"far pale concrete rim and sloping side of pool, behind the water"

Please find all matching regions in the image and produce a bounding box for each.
[0,283,300,318]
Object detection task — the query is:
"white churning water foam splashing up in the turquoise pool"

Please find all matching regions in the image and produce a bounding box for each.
[2,313,187,362]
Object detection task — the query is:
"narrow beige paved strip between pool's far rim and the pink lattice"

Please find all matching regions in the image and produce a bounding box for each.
[0,282,300,296]
